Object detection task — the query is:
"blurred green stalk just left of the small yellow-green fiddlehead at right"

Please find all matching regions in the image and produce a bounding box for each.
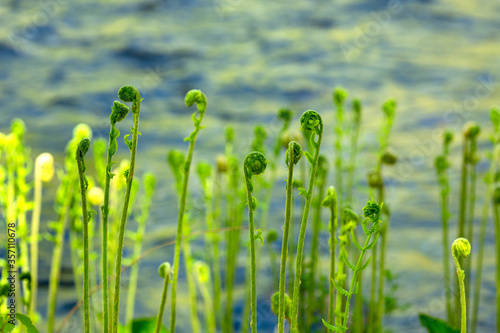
[434,131,453,322]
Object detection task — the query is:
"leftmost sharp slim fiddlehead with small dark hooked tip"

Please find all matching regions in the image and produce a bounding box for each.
[76,139,90,333]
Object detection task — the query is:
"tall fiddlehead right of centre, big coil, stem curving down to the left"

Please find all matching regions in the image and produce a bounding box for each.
[291,110,323,333]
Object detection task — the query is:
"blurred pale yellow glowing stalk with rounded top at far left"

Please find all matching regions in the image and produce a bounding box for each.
[28,153,54,318]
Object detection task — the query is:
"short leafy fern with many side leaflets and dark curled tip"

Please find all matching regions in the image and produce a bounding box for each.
[323,201,383,332]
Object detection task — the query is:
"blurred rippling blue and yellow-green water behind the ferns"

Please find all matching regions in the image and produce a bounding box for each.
[0,0,500,333]
